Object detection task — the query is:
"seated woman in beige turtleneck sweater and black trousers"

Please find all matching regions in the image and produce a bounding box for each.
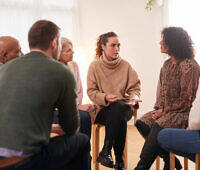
[87,32,140,170]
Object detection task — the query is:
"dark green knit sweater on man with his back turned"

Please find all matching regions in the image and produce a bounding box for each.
[0,52,79,154]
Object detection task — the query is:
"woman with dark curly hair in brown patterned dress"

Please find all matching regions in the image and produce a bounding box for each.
[135,27,200,170]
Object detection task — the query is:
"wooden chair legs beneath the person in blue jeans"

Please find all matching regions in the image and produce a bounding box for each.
[169,152,200,170]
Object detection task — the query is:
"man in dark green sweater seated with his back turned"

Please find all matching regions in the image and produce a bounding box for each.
[0,20,90,170]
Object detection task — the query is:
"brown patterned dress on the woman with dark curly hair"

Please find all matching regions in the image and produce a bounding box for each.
[140,59,200,128]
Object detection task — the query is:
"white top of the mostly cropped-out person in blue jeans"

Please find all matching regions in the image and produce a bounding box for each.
[189,80,200,130]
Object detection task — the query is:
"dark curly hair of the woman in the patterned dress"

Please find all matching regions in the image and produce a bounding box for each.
[161,27,194,61]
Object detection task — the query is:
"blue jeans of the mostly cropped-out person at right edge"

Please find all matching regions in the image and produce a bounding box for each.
[158,128,200,161]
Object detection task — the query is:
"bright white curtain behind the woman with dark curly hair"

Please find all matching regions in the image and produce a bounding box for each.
[168,0,200,63]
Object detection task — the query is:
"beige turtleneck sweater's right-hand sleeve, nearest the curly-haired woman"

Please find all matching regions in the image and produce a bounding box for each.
[126,65,141,99]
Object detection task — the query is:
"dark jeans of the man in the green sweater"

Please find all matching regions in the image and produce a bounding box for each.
[0,133,90,170]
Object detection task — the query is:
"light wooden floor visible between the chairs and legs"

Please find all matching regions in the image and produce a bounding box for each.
[92,125,195,170]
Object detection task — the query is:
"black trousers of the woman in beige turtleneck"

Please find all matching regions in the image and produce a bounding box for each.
[95,100,132,161]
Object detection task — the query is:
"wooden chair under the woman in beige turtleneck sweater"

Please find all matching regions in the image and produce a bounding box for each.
[92,108,138,170]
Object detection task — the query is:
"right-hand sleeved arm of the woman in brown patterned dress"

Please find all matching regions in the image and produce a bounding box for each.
[164,64,199,113]
